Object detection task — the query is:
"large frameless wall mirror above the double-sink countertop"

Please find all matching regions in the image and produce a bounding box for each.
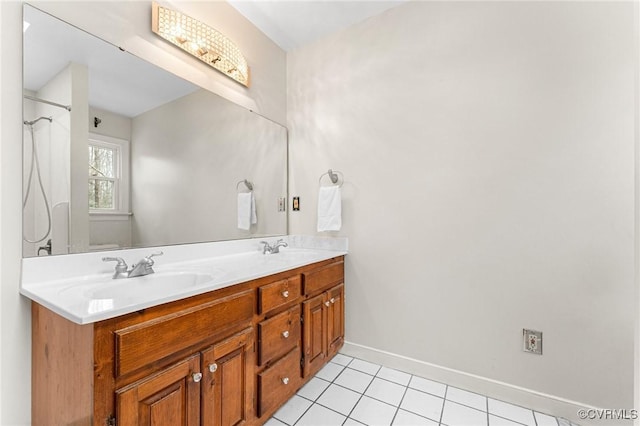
[23,5,287,257]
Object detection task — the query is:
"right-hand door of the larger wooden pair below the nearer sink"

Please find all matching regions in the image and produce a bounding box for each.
[202,328,255,426]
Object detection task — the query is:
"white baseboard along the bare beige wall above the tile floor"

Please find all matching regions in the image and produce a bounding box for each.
[340,342,612,426]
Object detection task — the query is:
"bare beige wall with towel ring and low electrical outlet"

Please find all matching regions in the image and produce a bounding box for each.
[287,2,636,408]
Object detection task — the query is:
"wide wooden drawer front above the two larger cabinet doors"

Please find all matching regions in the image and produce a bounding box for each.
[114,290,255,376]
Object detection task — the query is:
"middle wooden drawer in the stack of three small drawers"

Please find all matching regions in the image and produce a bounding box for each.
[258,305,300,365]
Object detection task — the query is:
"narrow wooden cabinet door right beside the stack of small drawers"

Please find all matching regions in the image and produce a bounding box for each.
[302,294,327,377]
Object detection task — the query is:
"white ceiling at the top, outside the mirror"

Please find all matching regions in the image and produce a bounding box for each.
[229,0,407,51]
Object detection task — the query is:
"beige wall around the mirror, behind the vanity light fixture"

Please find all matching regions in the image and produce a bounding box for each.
[0,1,286,425]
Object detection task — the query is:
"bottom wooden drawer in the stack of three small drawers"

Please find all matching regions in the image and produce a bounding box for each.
[258,348,302,416]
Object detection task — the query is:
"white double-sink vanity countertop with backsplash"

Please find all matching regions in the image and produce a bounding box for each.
[20,236,348,324]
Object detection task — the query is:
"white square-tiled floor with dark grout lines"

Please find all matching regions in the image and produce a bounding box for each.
[266,354,575,426]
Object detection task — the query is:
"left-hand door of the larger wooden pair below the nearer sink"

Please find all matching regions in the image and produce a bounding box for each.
[116,354,202,426]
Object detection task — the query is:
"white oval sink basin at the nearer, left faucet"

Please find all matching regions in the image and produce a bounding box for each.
[85,271,213,299]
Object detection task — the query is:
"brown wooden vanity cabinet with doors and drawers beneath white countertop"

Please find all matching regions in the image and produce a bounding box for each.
[25,243,344,426]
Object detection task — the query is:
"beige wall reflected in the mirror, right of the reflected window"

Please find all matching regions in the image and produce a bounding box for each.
[131,90,287,247]
